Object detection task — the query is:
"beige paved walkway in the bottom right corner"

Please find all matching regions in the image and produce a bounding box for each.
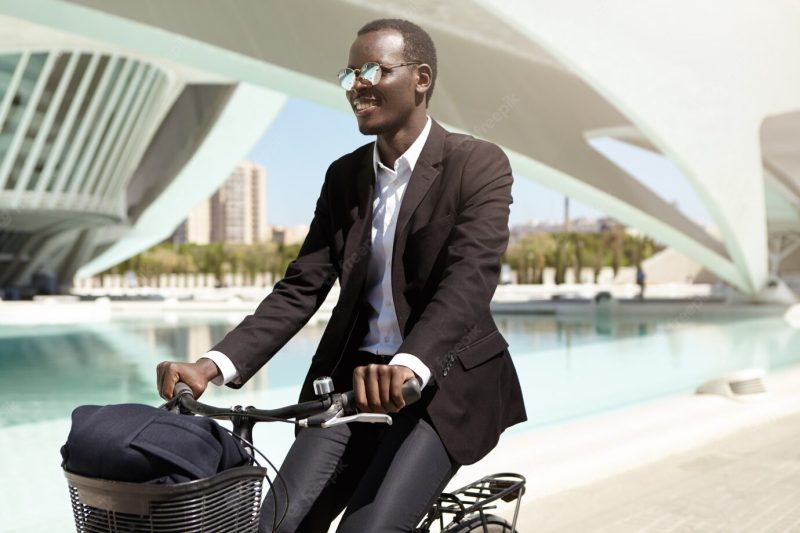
[517,414,800,533]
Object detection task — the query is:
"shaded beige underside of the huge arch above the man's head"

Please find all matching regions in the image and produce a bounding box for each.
[37,0,763,291]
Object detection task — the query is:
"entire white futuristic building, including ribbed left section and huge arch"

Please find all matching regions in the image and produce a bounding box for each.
[0,0,800,297]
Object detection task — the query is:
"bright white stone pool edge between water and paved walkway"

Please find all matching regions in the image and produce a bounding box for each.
[448,366,800,504]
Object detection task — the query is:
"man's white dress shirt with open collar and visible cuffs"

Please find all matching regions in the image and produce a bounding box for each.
[203,117,431,387]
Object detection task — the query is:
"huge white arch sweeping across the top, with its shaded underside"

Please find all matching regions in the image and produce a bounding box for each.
[2,0,800,294]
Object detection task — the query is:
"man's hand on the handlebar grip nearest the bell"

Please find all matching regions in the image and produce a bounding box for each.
[353,365,416,413]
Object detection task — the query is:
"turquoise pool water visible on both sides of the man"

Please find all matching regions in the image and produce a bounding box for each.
[0,313,800,427]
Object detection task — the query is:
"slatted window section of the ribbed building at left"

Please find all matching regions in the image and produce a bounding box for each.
[0,49,168,218]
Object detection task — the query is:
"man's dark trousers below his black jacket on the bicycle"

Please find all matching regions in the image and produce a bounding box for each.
[259,354,459,533]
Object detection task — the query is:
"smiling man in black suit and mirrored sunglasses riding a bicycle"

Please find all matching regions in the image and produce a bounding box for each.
[158,19,525,533]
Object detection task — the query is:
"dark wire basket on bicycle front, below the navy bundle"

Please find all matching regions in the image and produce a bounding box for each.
[64,466,267,533]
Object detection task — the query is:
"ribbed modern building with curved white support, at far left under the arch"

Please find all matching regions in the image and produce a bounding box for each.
[0,9,286,291]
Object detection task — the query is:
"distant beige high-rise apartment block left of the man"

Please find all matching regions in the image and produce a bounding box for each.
[172,161,268,244]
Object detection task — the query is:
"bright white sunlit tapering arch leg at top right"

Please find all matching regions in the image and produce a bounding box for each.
[482,0,800,292]
